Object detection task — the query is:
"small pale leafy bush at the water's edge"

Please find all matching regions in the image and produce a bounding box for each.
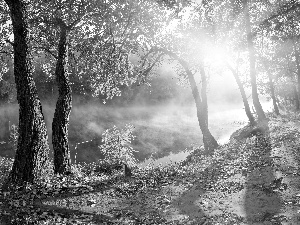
[99,124,136,167]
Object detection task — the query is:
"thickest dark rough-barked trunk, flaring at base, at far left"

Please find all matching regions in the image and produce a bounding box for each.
[5,0,49,187]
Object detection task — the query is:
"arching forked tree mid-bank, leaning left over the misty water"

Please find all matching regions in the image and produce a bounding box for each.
[132,1,218,151]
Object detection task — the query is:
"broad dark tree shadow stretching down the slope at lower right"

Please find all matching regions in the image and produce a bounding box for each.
[244,127,282,223]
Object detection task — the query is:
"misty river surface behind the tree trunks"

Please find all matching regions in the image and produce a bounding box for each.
[0,102,272,165]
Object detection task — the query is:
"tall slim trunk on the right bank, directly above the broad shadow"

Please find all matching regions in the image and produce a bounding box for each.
[245,1,266,121]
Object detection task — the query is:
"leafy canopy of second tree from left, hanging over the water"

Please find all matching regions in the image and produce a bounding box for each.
[22,0,172,103]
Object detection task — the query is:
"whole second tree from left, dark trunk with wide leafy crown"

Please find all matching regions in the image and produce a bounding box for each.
[28,0,171,173]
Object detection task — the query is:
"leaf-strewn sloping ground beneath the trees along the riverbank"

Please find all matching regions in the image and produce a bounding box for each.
[0,111,300,225]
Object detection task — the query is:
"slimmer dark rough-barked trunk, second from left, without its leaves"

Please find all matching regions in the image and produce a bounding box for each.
[52,20,72,174]
